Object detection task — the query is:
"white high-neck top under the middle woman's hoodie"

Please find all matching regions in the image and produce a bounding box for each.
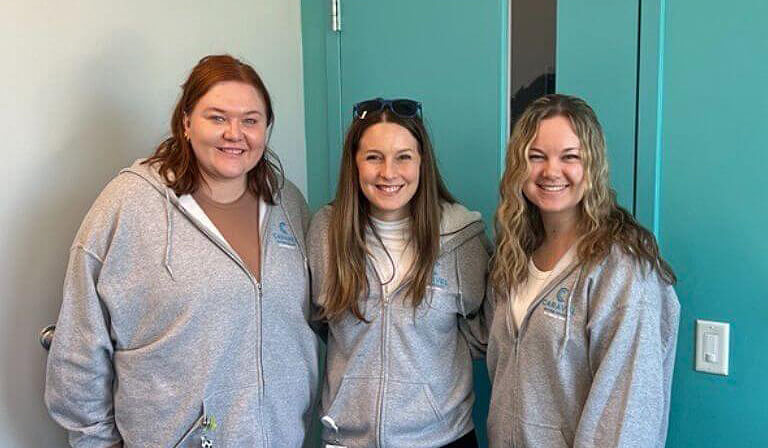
[365,217,413,294]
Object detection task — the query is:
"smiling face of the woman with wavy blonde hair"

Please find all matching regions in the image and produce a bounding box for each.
[523,116,586,220]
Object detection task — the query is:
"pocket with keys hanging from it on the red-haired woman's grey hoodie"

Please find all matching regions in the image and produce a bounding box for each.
[197,386,266,448]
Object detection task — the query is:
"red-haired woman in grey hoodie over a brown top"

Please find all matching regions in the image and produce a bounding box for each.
[45,55,318,447]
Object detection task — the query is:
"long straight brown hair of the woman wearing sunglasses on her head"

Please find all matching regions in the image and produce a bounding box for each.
[320,109,456,321]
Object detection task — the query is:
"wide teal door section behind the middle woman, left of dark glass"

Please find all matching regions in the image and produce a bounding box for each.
[330,0,507,223]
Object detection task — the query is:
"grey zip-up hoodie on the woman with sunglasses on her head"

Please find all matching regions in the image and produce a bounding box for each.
[307,204,490,448]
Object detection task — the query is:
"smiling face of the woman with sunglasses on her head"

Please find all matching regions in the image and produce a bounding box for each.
[355,122,421,221]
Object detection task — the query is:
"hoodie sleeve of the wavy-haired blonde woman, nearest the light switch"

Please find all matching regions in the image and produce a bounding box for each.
[574,259,679,447]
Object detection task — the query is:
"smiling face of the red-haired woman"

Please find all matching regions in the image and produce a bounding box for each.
[184,81,267,191]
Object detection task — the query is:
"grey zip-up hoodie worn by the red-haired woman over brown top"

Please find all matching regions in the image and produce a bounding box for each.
[45,161,318,448]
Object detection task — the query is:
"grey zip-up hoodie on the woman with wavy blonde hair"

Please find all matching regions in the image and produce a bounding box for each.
[474,247,680,448]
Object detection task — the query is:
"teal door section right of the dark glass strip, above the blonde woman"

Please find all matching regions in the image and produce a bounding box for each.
[555,0,640,213]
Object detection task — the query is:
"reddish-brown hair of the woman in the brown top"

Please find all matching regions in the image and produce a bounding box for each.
[144,54,283,205]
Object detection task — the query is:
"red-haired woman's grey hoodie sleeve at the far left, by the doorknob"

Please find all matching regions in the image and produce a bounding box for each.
[45,246,121,448]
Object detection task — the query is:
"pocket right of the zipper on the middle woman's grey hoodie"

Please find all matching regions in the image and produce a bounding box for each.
[382,381,443,435]
